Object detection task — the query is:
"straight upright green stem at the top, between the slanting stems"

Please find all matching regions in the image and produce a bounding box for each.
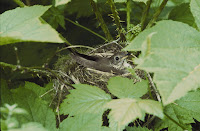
[126,0,131,31]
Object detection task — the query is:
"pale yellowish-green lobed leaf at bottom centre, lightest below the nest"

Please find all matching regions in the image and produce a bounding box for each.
[105,98,164,131]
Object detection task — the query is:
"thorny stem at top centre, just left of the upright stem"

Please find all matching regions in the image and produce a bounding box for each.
[108,0,126,41]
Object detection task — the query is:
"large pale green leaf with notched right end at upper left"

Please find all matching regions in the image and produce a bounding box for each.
[0,5,63,45]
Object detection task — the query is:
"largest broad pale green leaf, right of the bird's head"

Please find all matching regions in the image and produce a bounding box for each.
[125,21,200,105]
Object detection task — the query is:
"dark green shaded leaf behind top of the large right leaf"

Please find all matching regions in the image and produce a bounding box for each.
[168,3,195,26]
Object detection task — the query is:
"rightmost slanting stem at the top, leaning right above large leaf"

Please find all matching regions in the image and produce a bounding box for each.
[146,0,168,29]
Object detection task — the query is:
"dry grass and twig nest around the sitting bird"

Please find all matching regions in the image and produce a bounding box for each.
[55,42,144,93]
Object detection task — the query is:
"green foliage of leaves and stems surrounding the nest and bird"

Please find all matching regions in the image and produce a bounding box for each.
[0,0,200,131]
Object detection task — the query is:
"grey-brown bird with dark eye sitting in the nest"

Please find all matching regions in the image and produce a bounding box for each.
[71,51,128,75]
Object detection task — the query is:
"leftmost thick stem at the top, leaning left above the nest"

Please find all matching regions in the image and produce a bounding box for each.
[90,0,113,41]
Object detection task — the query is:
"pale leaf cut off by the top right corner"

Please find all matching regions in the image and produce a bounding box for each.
[190,0,200,30]
